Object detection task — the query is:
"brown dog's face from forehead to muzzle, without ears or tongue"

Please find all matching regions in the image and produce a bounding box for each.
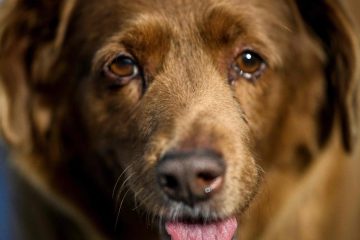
[79,1,323,232]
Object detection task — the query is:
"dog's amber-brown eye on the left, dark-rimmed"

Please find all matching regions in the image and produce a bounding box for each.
[105,55,139,85]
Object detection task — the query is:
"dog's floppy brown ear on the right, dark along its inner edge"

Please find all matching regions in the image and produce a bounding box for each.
[295,0,360,151]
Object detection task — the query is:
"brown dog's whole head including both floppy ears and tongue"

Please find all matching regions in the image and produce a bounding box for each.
[0,0,358,239]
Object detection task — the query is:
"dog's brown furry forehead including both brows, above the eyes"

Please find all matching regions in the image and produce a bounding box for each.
[74,0,293,67]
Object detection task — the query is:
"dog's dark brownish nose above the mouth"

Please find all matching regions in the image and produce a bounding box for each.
[157,150,225,206]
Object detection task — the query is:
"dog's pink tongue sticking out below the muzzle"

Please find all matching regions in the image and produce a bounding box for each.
[165,218,237,240]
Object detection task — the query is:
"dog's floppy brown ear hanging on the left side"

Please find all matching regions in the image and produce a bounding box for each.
[0,0,76,149]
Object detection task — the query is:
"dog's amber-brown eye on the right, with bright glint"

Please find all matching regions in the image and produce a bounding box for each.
[234,50,266,80]
